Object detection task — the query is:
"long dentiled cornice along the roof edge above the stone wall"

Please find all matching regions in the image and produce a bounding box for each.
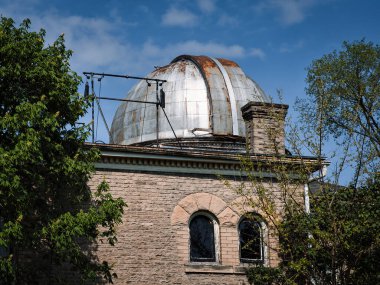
[90,145,324,178]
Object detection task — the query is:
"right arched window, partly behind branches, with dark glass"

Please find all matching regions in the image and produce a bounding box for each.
[239,216,265,263]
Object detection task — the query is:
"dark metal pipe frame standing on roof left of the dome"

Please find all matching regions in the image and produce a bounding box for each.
[83,72,182,149]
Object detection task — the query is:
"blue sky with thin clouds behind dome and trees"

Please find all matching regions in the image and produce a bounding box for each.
[0,0,380,181]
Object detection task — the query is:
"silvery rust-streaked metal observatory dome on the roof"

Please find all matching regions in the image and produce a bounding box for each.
[110,55,270,145]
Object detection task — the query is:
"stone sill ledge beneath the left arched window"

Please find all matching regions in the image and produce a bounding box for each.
[185,263,245,275]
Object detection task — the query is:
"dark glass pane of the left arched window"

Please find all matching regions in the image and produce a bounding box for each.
[190,216,215,261]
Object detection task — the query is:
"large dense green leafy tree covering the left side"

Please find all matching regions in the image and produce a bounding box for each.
[0,18,125,284]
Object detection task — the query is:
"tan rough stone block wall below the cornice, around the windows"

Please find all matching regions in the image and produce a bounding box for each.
[89,170,302,285]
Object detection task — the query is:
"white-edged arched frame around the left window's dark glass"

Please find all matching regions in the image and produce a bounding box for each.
[187,211,220,265]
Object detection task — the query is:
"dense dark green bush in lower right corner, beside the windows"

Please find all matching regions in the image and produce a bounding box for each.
[279,178,380,284]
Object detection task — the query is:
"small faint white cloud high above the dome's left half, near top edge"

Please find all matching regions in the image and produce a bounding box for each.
[162,7,198,27]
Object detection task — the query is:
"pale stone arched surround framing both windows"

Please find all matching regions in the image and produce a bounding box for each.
[170,192,279,266]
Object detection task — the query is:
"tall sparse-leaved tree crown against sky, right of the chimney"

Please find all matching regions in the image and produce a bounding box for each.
[297,40,380,185]
